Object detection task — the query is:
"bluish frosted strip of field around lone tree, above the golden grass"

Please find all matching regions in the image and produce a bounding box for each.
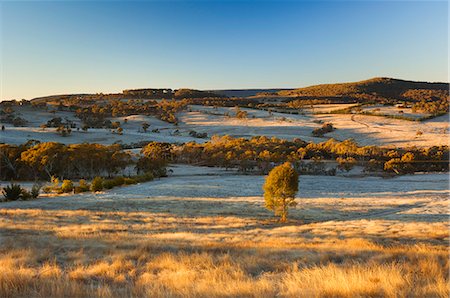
[0,165,450,230]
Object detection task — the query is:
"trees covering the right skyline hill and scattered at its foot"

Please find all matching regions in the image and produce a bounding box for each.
[253,78,449,120]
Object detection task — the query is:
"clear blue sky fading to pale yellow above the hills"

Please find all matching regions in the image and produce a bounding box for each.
[0,0,448,99]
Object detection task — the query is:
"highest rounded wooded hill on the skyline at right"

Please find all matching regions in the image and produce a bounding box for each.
[268,78,449,98]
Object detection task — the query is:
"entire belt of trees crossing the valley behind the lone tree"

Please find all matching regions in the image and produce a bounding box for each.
[0,136,449,180]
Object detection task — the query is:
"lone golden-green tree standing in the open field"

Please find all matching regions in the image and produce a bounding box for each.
[263,162,298,222]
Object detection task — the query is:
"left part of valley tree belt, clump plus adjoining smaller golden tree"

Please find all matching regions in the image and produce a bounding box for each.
[0,142,170,180]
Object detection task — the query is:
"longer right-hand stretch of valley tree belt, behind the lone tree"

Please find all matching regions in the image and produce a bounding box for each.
[173,136,449,174]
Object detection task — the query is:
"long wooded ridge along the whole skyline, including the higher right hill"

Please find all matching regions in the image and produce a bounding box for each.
[26,78,449,102]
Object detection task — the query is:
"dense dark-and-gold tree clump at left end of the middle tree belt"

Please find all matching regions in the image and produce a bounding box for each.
[0,142,133,180]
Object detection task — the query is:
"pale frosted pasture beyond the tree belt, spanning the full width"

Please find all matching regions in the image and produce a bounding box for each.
[0,105,449,147]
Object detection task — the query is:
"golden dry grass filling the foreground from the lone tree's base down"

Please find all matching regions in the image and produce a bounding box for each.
[0,200,450,297]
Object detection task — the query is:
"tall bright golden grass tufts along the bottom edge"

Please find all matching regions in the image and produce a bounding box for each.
[0,244,449,297]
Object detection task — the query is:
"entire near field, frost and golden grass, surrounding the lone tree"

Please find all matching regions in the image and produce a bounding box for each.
[0,165,450,297]
